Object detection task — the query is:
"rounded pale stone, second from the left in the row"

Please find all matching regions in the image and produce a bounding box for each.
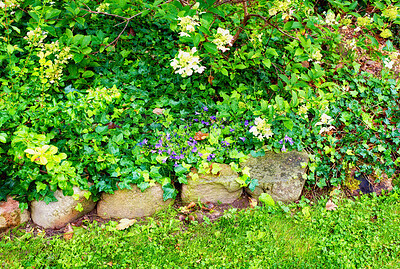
[31,187,96,229]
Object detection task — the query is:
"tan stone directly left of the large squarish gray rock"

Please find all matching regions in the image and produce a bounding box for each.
[181,164,243,204]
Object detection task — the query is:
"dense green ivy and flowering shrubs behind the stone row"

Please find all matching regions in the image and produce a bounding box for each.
[0,0,400,207]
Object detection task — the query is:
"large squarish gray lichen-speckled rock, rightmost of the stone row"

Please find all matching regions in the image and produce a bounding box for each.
[243,151,308,202]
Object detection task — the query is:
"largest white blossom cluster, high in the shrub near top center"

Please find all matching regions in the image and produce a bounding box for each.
[171,47,206,77]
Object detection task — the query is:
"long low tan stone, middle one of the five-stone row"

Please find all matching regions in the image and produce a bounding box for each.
[97,184,173,219]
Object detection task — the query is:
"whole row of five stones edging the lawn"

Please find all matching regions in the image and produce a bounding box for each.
[0,151,308,229]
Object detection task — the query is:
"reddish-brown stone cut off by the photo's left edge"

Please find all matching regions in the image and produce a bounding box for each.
[0,196,30,232]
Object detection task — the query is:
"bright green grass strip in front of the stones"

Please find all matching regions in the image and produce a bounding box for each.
[0,189,400,268]
